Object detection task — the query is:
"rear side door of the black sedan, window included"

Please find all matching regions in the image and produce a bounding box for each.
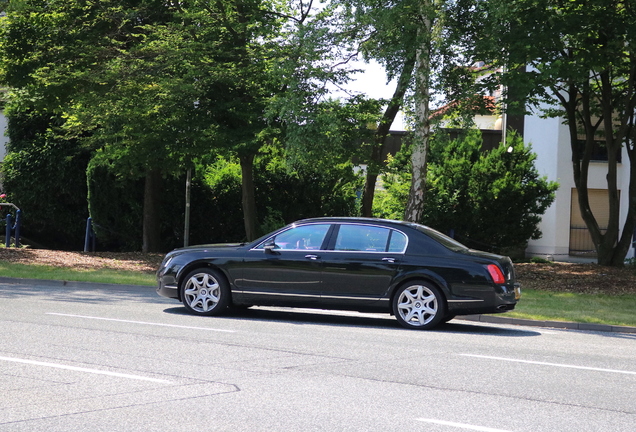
[321,224,407,307]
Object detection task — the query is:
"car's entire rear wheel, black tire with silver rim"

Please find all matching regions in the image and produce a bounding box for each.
[393,281,446,330]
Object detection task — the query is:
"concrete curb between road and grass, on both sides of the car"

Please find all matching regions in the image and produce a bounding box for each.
[0,276,636,334]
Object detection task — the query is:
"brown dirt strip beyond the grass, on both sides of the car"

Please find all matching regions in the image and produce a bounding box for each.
[0,248,636,295]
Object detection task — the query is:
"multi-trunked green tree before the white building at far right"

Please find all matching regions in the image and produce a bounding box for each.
[467,0,636,266]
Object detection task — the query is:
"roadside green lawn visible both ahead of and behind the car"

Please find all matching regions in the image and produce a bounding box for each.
[0,261,636,326]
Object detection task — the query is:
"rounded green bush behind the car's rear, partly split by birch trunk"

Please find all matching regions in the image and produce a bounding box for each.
[378,131,558,252]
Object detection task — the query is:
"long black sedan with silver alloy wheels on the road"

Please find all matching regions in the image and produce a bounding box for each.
[157,218,521,329]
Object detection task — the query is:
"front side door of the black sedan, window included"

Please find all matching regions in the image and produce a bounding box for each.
[239,223,331,305]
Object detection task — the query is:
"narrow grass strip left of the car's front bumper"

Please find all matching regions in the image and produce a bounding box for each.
[0,261,156,286]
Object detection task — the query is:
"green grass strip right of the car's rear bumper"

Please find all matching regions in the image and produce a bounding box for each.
[505,289,636,327]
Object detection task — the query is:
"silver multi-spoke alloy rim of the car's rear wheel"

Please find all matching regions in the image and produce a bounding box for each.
[397,285,439,327]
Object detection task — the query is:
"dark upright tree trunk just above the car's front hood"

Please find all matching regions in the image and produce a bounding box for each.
[141,168,162,252]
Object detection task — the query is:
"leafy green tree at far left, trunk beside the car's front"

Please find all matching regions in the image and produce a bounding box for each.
[0,1,204,251]
